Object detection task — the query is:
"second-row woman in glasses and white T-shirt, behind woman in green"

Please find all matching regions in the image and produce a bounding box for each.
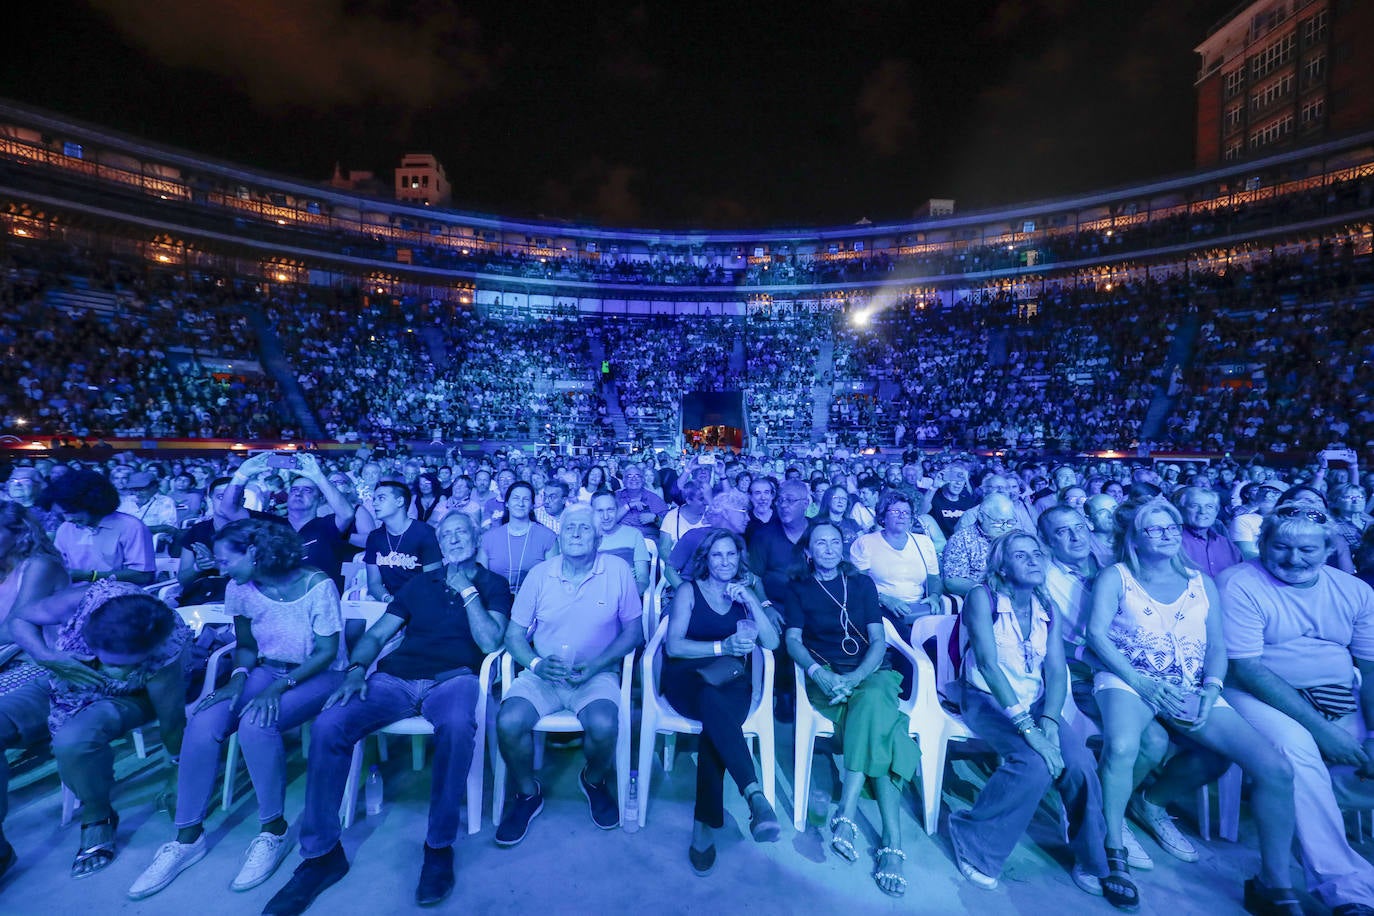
[849,490,944,626]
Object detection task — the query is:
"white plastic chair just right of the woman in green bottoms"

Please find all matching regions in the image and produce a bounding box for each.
[882,615,977,835]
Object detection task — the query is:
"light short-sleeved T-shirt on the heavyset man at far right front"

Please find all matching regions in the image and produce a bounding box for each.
[1217,559,1374,688]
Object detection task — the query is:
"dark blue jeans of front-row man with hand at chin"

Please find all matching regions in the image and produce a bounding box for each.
[301,672,478,858]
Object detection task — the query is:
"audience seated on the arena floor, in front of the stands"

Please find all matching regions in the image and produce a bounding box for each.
[0,448,1374,916]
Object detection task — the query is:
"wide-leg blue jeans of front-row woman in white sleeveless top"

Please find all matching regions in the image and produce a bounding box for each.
[949,687,1107,878]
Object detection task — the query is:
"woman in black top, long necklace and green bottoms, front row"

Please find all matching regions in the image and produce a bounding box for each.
[786,522,919,897]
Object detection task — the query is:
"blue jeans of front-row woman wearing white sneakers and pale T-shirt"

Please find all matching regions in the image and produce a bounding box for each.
[176,665,344,828]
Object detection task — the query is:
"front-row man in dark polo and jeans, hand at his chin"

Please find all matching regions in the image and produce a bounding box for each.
[262,513,511,916]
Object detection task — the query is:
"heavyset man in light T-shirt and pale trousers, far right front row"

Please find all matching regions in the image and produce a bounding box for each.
[1217,503,1374,916]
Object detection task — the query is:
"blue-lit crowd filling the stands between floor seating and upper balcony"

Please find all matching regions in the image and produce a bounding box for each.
[0,234,1374,453]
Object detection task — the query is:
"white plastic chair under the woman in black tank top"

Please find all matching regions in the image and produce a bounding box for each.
[639,618,778,827]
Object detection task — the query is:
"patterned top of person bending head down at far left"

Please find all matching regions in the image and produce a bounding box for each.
[48,585,191,732]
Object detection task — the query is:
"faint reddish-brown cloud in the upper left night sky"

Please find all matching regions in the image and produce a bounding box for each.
[91,0,492,110]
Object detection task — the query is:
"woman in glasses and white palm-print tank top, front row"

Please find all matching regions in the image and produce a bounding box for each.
[1088,497,1303,915]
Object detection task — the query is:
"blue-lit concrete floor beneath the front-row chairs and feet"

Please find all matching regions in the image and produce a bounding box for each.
[0,726,1335,916]
